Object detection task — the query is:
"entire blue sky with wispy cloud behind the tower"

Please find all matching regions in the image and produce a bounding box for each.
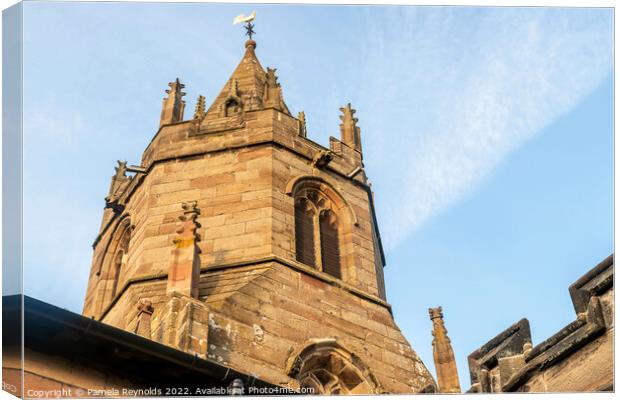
[17,2,613,389]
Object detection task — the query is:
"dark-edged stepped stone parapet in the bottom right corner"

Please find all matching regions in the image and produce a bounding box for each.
[468,255,614,393]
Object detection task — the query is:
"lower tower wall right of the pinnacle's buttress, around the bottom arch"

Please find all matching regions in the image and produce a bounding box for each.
[205,262,434,393]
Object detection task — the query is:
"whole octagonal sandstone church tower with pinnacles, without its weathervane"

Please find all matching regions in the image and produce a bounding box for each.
[83,36,435,393]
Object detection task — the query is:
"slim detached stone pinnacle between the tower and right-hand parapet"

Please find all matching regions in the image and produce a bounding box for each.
[428,307,461,393]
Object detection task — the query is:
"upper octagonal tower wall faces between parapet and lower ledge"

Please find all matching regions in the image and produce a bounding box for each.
[84,111,383,315]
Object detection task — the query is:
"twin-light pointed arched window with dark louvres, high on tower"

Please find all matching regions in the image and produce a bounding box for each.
[295,189,342,279]
